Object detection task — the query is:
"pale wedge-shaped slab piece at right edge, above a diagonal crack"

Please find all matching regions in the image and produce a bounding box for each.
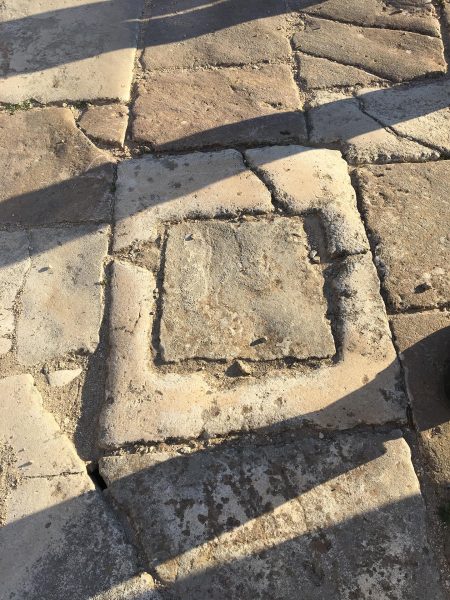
[359,79,450,154]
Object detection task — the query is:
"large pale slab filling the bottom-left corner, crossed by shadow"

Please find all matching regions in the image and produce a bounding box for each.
[0,375,157,600]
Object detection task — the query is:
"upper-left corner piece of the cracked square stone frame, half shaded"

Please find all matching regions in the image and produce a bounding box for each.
[114,150,273,251]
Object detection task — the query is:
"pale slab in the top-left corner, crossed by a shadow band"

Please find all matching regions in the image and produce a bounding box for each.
[0,0,143,103]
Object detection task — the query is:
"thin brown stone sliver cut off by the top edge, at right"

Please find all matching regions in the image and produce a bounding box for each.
[288,0,440,36]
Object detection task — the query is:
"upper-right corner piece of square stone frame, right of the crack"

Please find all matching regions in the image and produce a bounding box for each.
[245,146,368,256]
